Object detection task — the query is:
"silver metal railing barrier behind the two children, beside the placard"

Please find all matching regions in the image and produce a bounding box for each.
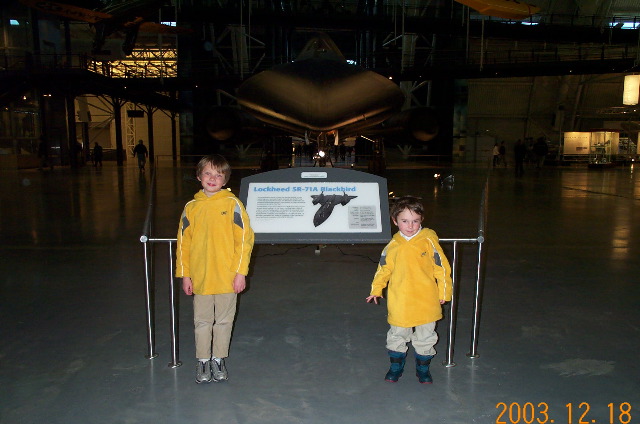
[140,167,489,368]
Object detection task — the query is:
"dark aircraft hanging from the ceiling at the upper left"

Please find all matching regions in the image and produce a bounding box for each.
[20,0,191,55]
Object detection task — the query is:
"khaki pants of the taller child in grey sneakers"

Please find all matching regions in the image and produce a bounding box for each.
[193,293,238,359]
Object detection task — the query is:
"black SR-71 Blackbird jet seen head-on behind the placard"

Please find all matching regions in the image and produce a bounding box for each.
[207,33,438,154]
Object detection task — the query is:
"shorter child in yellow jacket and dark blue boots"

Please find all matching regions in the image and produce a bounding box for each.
[366,196,451,384]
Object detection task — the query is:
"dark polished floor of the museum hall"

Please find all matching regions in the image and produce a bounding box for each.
[0,157,640,424]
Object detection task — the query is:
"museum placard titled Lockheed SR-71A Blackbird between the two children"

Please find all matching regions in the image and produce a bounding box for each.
[240,168,390,243]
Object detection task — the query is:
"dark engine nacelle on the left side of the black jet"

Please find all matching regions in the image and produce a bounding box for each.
[207,106,265,141]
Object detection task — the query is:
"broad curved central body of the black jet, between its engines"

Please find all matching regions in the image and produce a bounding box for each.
[238,58,404,133]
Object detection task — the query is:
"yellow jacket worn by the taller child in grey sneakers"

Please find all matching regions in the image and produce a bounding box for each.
[176,190,254,294]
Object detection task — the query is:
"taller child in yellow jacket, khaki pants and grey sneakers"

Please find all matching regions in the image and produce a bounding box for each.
[176,155,254,383]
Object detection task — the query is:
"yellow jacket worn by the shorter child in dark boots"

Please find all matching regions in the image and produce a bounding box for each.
[371,228,451,327]
